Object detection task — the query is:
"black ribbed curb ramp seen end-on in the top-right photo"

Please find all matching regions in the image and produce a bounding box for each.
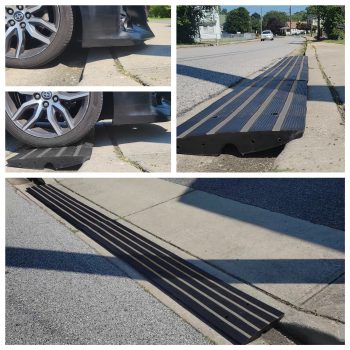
[177,56,308,154]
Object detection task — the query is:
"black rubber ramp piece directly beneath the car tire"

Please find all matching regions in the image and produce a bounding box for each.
[7,142,93,170]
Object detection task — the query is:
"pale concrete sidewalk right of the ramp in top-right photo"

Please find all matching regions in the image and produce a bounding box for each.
[274,43,345,172]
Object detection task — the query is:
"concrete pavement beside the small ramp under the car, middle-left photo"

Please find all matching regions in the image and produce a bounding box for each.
[6,121,171,172]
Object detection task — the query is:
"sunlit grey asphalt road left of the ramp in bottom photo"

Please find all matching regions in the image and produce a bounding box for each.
[6,184,208,345]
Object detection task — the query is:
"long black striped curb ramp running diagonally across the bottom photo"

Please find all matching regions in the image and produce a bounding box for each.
[27,185,283,344]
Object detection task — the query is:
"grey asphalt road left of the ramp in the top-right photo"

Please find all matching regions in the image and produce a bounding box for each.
[177,37,304,115]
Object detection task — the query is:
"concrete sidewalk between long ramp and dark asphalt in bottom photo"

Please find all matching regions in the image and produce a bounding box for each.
[51,179,345,343]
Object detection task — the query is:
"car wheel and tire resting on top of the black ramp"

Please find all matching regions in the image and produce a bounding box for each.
[6,92,103,147]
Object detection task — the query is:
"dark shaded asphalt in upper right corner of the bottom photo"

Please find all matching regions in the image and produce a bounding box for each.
[168,178,345,230]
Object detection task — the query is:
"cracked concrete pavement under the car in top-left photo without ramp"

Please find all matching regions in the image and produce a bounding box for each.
[6,20,171,86]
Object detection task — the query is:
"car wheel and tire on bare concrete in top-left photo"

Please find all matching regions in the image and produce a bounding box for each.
[5,6,74,68]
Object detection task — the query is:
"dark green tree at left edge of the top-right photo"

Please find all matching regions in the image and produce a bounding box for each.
[176,6,214,44]
